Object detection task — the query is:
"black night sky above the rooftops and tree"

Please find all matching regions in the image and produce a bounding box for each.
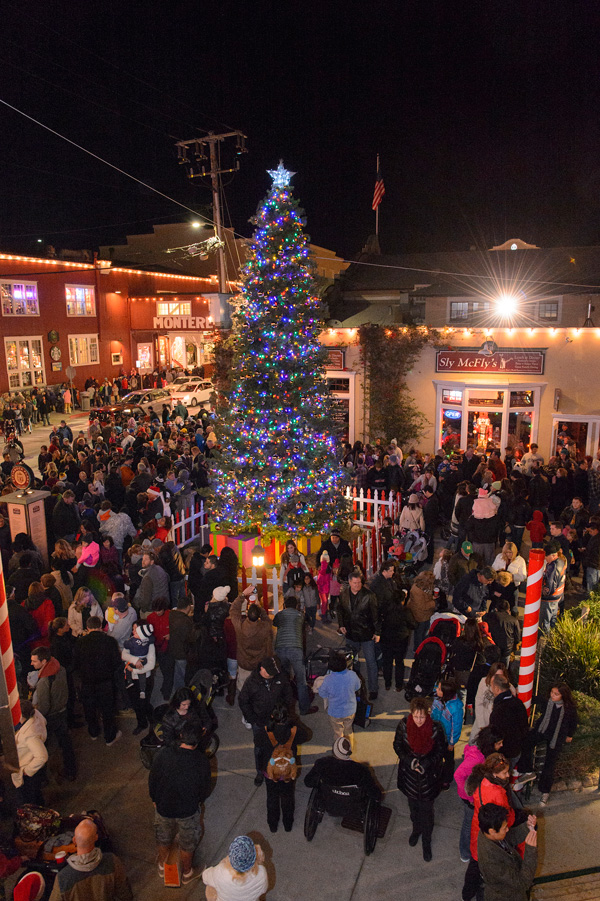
[0,0,600,258]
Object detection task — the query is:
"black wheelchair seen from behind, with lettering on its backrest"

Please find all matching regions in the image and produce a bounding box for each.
[304,782,381,856]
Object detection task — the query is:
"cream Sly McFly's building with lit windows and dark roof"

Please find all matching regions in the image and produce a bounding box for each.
[323,239,600,458]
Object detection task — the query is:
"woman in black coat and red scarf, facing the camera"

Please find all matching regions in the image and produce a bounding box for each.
[394,697,446,861]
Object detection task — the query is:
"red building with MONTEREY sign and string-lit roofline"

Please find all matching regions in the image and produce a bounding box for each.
[0,253,224,393]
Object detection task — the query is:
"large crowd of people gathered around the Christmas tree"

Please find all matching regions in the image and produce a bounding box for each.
[0,411,584,901]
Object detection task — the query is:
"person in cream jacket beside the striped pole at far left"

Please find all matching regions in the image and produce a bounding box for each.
[11,701,48,807]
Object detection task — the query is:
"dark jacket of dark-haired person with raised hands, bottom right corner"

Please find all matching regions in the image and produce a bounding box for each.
[477,823,537,901]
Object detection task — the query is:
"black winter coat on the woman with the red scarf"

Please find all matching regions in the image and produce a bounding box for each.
[394,717,446,801]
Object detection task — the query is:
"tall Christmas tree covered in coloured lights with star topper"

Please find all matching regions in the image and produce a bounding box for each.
[211,162,347,536]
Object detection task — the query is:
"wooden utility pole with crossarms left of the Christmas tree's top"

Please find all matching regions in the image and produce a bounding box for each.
[175,131,248,294]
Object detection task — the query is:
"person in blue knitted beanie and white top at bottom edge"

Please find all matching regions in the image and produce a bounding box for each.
[202,835,269,901]
